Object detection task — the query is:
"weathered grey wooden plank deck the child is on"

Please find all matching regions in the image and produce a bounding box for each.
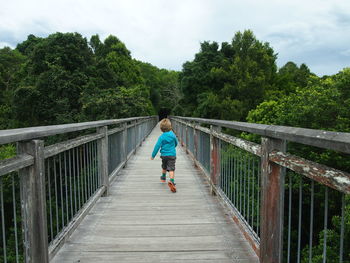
[52,127,259,263]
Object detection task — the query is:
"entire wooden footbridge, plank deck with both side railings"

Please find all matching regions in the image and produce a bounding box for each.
[0,117,350,263]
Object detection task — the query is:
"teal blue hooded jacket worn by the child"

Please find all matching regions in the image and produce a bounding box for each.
[152,131,178,158]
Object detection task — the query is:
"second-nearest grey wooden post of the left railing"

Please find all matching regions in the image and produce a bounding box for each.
[97,126,109,196]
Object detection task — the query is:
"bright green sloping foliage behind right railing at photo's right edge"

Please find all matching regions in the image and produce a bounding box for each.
[247,69,350,132]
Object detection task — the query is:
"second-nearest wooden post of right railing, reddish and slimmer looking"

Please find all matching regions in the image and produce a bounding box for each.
[210,125,221,194]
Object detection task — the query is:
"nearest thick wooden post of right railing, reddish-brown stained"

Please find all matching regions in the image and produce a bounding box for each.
[260,138,286,263]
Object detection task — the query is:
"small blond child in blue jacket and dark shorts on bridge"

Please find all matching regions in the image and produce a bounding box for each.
[151,118,178,193]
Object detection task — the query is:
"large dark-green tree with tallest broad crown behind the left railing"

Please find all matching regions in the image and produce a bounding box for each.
[13,33,93,127]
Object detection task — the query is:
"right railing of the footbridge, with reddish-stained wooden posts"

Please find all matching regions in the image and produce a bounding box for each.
[171,117,350,263]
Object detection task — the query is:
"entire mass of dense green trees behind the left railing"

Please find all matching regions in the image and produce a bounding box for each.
[0,33,180,128]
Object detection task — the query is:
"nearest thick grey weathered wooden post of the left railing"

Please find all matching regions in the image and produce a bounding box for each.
[17,140,49,263]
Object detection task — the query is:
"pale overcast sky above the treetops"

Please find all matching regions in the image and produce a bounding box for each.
[0,0,350,76]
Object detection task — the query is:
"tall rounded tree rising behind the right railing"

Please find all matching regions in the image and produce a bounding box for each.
[181,30,276,120]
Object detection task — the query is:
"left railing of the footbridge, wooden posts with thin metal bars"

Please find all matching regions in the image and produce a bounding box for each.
[0,117,157,263]
